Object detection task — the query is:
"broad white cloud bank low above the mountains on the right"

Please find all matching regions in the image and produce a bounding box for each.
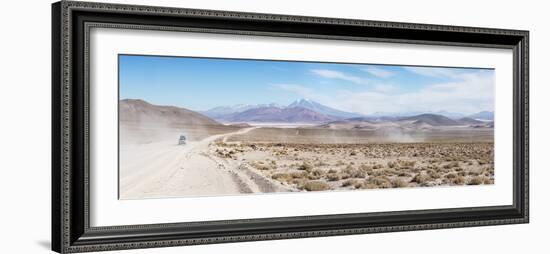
[276,68,495,114]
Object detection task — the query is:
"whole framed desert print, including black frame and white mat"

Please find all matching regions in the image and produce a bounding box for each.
[52,1,529,253]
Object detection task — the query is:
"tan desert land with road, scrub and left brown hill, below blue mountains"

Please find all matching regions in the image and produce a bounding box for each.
[119,100,494,199]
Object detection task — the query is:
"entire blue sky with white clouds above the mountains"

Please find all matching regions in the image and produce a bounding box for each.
[119,55,494,114]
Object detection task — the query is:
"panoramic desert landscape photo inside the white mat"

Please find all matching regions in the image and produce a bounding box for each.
[118,55,495,199]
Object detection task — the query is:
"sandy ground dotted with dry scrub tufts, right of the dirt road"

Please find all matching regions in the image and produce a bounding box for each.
[216,142,494,191]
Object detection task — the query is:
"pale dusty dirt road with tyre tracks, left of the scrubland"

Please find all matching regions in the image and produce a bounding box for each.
[119,127,294,199]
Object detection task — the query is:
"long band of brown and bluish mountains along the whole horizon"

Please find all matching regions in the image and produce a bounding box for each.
[123,99,494,130]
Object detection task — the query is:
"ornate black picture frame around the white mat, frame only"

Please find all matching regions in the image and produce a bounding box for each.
[52,1,529,253]
